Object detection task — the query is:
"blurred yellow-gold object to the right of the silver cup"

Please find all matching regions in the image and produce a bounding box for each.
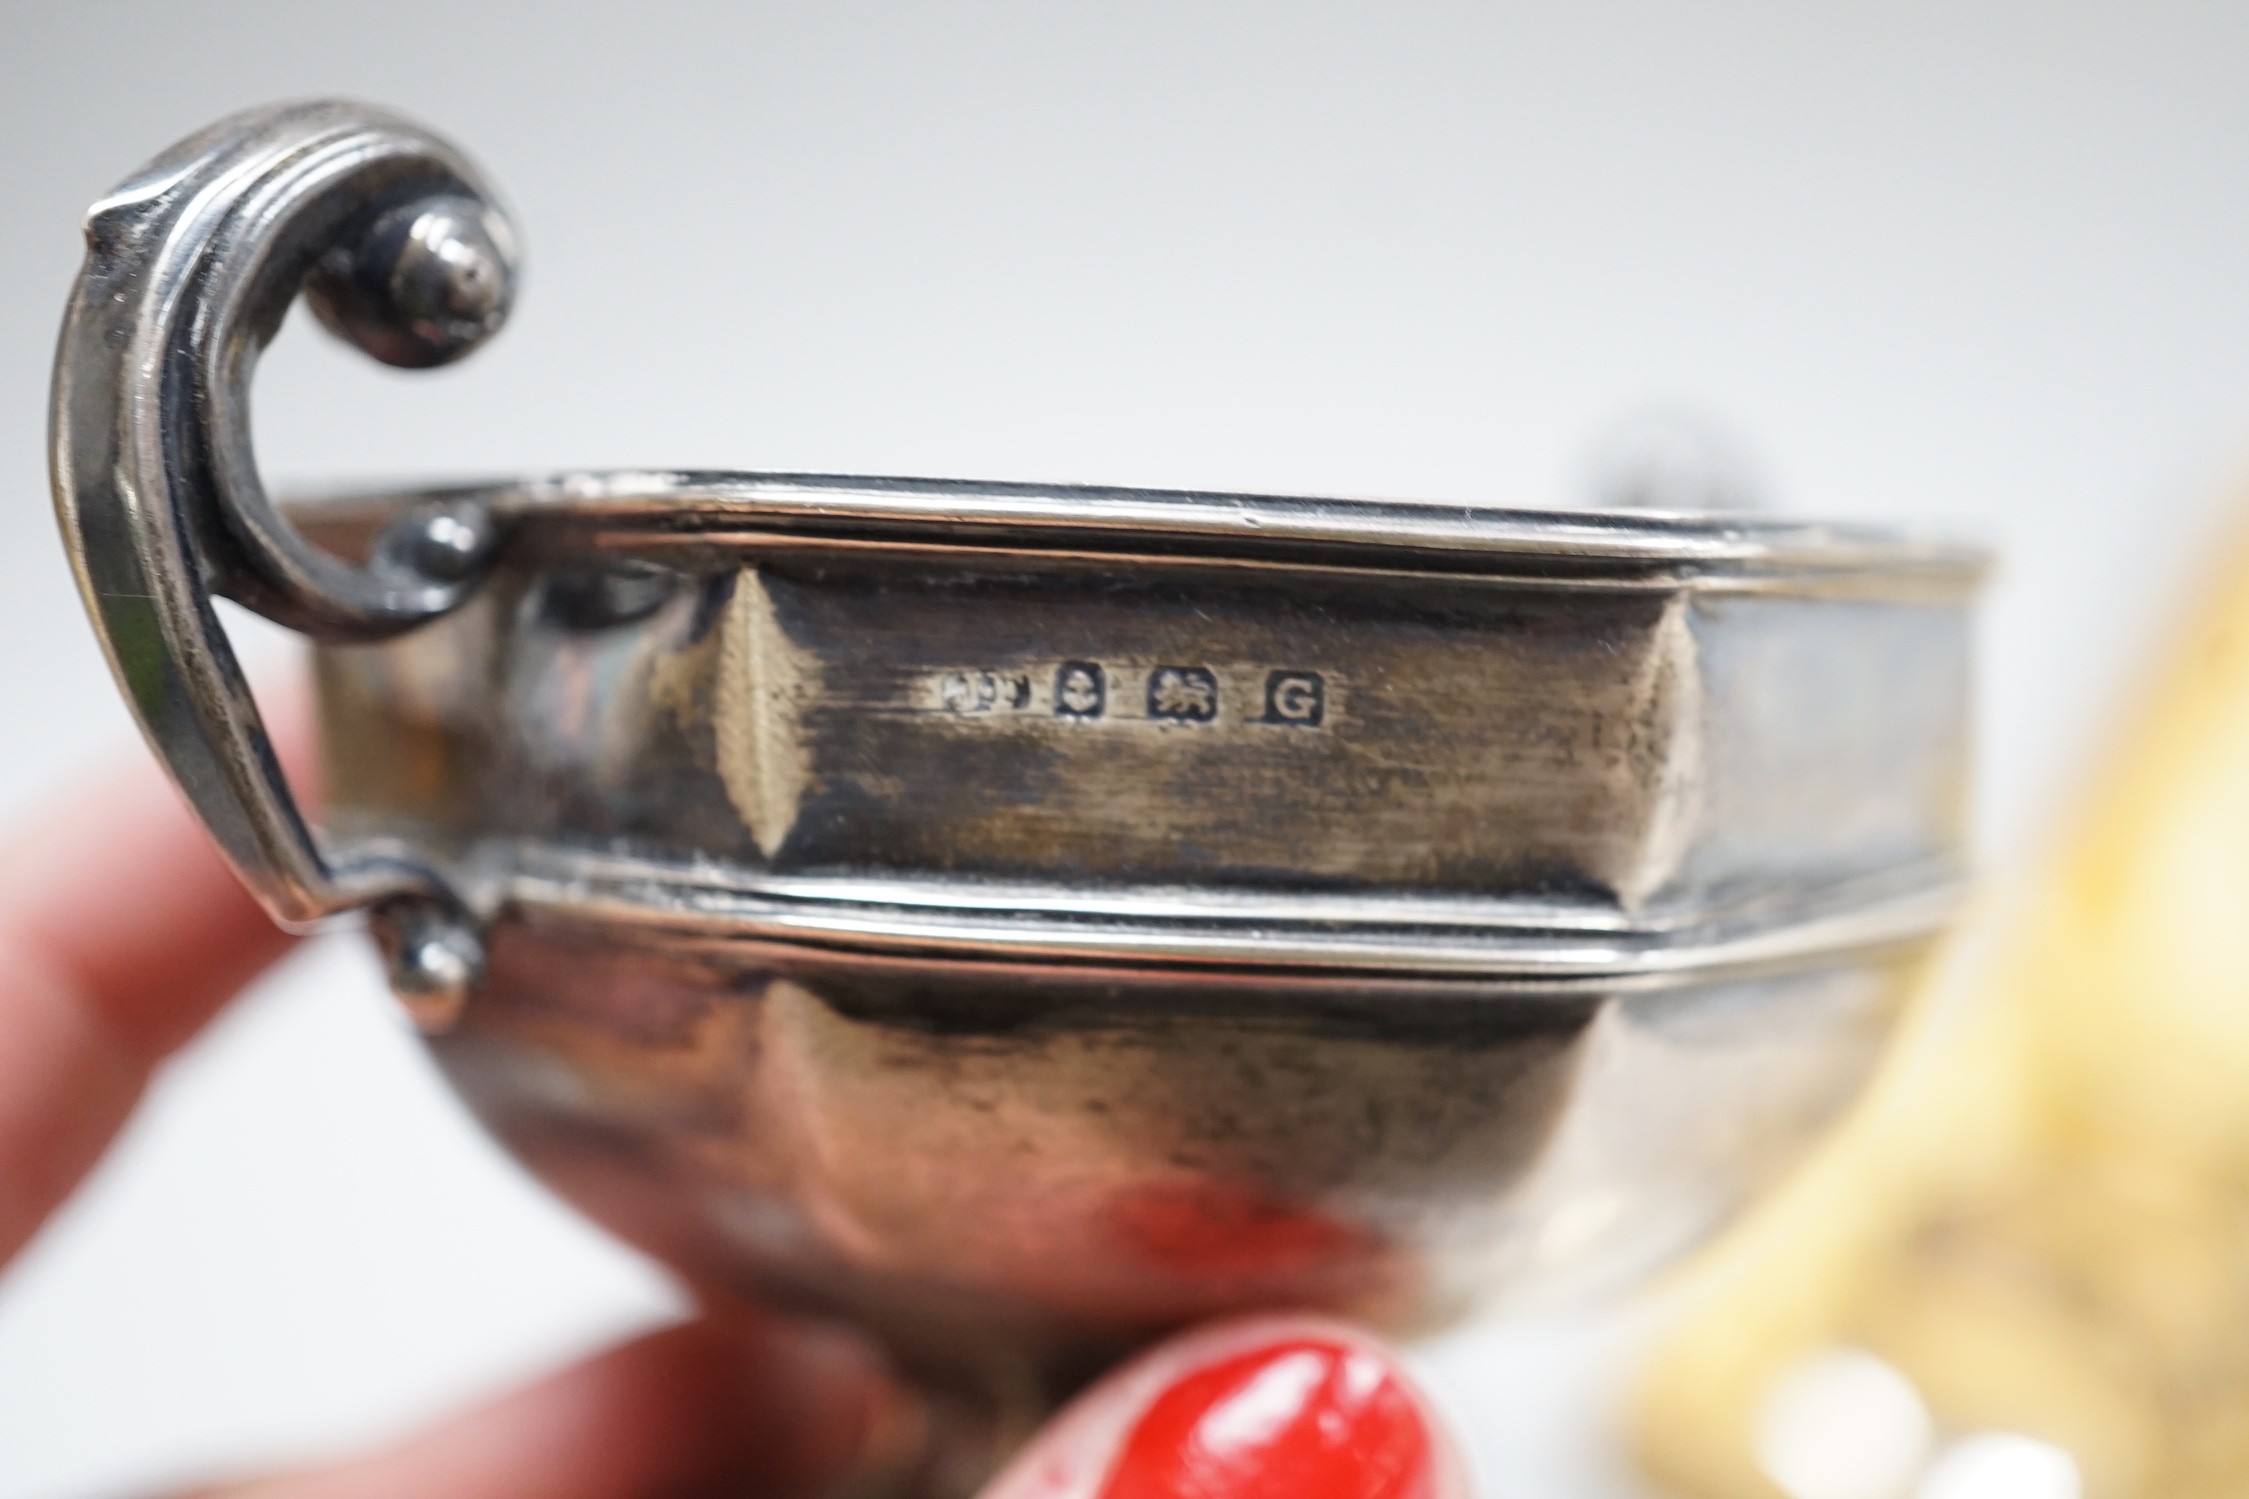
[1633,519,2249,1499]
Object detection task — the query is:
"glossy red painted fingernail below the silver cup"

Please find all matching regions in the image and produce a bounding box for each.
[1102,1337,1437,1499]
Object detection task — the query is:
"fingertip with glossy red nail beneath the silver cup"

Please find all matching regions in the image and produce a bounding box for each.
[983,1317,1469,1499]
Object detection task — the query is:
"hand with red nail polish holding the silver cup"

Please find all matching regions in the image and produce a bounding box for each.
[0,719,1466,1499]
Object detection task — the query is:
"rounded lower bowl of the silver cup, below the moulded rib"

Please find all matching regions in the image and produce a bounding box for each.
[434,921,1916,1427]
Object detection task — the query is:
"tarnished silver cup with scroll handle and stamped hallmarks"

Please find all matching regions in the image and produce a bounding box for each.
[54,103,1981,1492]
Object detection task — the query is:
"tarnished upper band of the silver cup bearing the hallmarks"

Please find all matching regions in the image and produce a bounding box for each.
[304,474,1972,948]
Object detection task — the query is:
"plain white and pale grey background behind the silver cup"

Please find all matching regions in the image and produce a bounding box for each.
[0,0,2249,1499]
